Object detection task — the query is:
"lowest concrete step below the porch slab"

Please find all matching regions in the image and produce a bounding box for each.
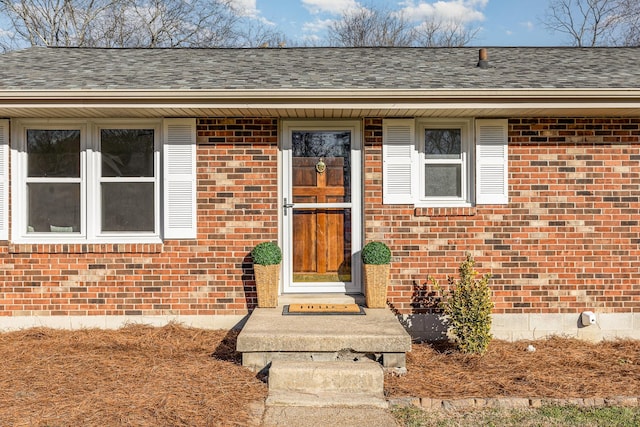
[267,360,388,408]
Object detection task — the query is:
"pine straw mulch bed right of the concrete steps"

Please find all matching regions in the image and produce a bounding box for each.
[385,337,640,399]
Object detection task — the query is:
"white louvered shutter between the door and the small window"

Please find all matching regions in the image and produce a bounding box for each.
[382,119,418,205]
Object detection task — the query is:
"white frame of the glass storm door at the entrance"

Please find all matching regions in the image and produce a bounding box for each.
[280,120,363,294]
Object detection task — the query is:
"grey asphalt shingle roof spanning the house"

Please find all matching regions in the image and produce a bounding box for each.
[0,47,640,90]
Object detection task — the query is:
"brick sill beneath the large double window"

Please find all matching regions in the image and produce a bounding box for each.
[9,243,164,254]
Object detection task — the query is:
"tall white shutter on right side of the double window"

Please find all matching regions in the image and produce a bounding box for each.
[162,119,197,239]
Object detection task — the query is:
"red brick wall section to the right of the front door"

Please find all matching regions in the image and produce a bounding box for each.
[365,118,640,313]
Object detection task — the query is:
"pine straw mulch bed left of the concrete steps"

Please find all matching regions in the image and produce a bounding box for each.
[0,324,267,426]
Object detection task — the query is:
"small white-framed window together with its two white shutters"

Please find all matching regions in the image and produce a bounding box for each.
[382,119,508,207]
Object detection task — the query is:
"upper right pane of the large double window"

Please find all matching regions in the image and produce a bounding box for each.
[100,129,154,177]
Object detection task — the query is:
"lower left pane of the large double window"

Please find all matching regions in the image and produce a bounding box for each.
[27,183,80,233]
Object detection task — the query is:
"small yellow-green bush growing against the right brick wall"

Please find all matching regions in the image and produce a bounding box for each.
[431,254,493,354]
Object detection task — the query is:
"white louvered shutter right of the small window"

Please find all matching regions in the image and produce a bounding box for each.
[476,119,509,205]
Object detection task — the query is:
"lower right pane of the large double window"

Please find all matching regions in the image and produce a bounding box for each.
[101,182,155,232]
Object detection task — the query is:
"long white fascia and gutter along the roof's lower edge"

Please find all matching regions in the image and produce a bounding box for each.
[0,89,640,116]
